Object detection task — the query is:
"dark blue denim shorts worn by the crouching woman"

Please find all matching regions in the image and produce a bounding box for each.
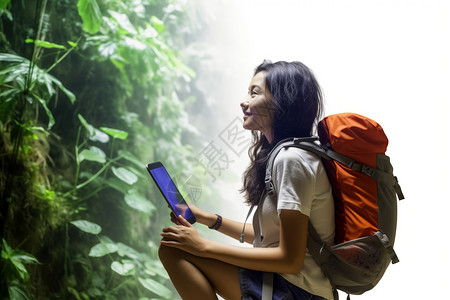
[239,268,326,300]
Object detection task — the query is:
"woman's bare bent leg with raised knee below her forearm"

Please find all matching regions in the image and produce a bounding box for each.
[159,246,241,300]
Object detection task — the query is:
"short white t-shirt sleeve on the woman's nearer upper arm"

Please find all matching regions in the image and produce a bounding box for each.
[274,148,315,217]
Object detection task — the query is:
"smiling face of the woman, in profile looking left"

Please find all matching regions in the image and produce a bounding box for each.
[241,71,273,142]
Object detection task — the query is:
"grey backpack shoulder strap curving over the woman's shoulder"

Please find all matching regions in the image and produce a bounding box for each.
[264,136,331,193]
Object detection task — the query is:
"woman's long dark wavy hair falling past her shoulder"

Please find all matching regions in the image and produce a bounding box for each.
[240,60,323,204]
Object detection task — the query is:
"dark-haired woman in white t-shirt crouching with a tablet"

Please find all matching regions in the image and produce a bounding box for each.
[159,61,334,299]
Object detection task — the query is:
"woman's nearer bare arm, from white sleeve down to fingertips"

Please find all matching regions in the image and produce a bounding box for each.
[161,210,308,274]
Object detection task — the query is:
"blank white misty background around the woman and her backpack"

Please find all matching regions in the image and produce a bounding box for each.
[191,0,450,300]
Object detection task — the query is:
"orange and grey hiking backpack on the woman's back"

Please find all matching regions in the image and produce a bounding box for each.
[265,113,404,299]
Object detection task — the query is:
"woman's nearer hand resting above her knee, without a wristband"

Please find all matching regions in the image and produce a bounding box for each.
[161,216,207,256]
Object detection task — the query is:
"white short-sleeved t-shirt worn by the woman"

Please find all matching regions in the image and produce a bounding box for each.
[253,147,335,299]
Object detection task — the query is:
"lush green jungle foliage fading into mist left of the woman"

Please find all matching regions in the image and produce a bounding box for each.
[0,0,236,300]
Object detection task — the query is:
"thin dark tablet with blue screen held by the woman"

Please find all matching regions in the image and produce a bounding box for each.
[146,162,195,224]
